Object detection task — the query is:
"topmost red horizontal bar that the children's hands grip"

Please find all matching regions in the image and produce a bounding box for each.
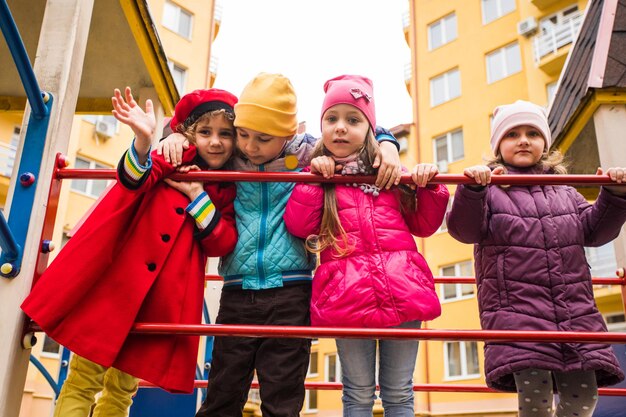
[56,168,626,186]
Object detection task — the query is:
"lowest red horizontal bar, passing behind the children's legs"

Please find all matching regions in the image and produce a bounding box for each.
[139,379,626,397]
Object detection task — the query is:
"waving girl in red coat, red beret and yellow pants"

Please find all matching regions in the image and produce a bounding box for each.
[22,87,237,417]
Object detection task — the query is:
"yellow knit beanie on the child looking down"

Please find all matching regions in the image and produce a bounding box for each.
[235,72,298,137]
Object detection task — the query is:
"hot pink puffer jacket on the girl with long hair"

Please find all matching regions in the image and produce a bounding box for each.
[284,179,450,328]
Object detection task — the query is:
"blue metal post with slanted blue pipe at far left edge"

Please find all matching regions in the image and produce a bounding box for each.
[0,0,53,278]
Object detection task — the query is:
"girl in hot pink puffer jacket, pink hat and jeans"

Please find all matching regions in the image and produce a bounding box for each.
[284,75,449,417]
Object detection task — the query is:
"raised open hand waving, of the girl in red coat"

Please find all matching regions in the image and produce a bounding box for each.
[111,87,156,151]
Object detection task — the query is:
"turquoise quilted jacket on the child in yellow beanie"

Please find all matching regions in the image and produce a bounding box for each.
[219,134,317,290]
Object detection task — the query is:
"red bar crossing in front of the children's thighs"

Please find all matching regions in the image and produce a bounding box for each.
[120,323,626,344]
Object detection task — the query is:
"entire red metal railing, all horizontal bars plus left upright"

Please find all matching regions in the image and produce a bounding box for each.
[25,155,626,396]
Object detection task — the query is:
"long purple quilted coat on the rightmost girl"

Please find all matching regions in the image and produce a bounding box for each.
[448,165,626,392]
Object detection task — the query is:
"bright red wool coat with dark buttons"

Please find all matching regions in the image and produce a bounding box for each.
[22,148,237,392]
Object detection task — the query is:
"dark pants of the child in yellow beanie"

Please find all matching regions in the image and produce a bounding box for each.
[196,283,311,417]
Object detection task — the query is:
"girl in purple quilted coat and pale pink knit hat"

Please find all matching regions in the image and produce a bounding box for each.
[448,101,626,417]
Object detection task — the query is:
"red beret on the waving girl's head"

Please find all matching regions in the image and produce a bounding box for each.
[170,88,237,131]
